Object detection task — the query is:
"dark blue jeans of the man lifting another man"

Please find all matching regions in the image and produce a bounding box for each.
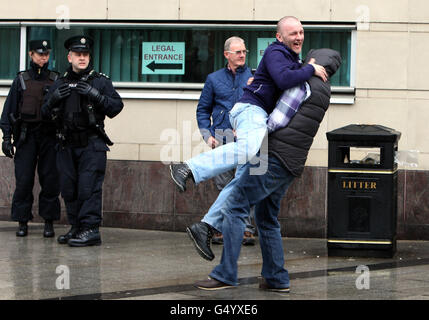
[210,156,294,288]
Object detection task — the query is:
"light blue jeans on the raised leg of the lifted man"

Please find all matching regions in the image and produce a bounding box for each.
[185,103,268,184]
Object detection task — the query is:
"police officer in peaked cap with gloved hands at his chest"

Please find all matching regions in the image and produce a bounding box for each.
[42,36,123,247]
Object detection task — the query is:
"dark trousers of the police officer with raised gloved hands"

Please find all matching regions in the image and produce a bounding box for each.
[57,136,109,228]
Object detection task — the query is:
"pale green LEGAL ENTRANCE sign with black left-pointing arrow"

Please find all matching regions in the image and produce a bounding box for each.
[142,42,185,75]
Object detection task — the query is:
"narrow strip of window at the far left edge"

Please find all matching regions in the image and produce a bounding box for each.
[0,27,21,79]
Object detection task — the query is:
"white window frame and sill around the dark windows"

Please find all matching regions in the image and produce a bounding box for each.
[0,21,357,104]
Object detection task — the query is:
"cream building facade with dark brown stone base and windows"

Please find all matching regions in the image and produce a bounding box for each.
[0,0,429,239]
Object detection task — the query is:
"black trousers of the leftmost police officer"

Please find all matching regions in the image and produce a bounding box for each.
[11,126,61,221]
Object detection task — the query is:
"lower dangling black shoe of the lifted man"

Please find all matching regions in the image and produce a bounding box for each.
[186,222,214,261]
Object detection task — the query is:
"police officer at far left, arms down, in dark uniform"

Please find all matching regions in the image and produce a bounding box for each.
[0,40,60,237]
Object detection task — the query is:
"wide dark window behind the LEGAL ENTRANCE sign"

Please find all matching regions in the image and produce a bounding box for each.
[26,24,352,87]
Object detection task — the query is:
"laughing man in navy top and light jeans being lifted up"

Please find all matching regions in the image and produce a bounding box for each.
[182,17,327,260]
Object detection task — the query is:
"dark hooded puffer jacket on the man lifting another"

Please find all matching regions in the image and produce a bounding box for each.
[268,49,341,176]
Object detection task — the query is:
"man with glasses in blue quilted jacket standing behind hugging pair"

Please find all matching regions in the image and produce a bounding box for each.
[197,37,255,245]
